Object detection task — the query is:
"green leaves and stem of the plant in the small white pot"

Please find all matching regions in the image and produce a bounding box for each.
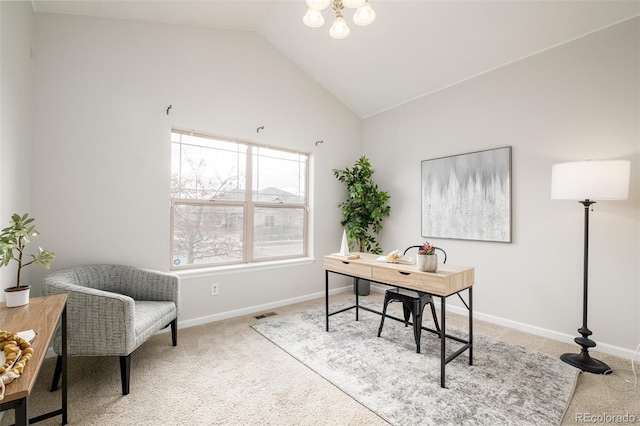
[0,213,55,288]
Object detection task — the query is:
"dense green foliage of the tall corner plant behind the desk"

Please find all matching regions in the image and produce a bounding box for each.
[333,156,391,254]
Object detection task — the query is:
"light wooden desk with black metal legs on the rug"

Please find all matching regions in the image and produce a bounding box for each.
[324,253,475,387]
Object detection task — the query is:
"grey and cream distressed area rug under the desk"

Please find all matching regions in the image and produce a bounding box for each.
[253,301,579,426]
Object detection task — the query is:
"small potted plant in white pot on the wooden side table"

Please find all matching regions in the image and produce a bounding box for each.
[0,213,55,308]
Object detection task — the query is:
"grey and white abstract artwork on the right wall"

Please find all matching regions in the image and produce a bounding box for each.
[422,147,511,242]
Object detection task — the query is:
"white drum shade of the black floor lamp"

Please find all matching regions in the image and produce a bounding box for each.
[551,160,631,201]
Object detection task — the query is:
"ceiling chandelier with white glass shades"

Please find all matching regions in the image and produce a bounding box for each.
[302,0,376,39]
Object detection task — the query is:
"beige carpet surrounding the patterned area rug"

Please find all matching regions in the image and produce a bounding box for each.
[0,293,640,426]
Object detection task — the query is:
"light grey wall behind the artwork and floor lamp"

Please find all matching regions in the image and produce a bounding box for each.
[364,18,640,350]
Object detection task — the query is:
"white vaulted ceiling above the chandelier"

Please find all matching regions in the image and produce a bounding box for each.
[32,0,640,117]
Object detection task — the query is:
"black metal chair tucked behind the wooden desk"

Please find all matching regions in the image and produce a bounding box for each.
[378,245,447,353]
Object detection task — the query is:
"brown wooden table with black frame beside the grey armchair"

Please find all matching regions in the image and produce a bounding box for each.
[0,294,67,425]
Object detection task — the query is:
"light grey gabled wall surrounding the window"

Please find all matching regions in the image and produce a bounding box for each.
[28,13,362,325]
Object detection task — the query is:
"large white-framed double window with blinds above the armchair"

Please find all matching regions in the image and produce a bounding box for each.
[171,130,309,269]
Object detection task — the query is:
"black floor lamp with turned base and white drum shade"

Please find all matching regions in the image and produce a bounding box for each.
[551,160,630,374]
